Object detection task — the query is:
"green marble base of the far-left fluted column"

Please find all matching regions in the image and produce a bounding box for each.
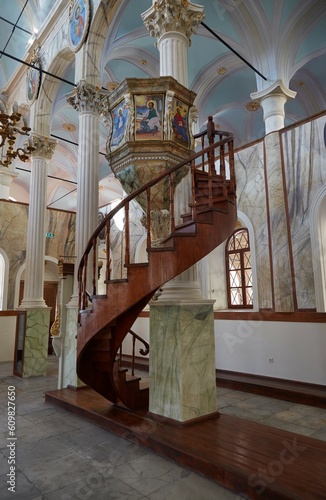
[22,307,51,378]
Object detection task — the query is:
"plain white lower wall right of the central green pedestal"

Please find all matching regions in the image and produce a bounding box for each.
[215,320,326,385]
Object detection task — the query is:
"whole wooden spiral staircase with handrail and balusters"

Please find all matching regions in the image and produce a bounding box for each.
[77,117,236,410]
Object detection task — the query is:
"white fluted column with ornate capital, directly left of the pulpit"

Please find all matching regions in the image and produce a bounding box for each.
[62,80,109,387]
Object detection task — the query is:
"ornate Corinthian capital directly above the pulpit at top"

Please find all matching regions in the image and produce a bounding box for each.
[142,0,205,45]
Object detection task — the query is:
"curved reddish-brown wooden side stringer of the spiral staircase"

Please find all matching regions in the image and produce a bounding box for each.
[77,195,236,410]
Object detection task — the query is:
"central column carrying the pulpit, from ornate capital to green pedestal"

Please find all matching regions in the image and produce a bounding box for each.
[142,0,216,422]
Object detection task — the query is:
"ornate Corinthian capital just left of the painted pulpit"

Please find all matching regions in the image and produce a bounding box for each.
[67,80,110,115]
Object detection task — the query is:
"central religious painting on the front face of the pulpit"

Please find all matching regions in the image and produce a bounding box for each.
[135,94,163,140]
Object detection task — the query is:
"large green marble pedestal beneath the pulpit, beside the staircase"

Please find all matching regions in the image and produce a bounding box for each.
[149,301,217,422]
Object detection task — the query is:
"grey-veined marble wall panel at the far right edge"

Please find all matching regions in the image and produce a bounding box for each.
[282,116,326,309]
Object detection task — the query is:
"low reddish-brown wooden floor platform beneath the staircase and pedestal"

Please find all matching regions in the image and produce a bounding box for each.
[45,388,326,500]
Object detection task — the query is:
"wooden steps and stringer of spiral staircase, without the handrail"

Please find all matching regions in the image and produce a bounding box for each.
[77,147,236,410]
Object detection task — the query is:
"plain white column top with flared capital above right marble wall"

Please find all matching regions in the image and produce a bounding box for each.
[250,80,297,135]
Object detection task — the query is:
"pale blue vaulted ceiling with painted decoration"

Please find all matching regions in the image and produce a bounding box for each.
[0,0,326,210]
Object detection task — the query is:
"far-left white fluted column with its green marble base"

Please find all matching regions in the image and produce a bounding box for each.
[20,132,57,377]
